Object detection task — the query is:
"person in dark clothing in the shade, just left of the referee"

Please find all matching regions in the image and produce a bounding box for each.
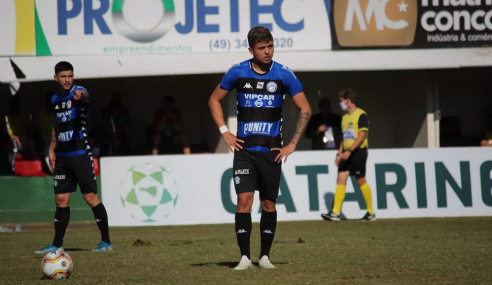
[306,98,342,150]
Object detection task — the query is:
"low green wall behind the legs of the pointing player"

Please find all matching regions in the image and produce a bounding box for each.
[0,177,101,224]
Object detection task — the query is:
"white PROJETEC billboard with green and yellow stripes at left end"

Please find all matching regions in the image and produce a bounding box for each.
[0,0,331,55]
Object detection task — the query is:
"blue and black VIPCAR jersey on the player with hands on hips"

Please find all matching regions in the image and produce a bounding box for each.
[220,60,303,151]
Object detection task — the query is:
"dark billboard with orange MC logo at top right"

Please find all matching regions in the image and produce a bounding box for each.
[331,0,492,49]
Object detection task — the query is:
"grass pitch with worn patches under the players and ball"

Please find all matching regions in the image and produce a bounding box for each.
[0,218,492,284]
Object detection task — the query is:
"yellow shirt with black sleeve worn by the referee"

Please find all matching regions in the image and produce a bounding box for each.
[342,108,369,150]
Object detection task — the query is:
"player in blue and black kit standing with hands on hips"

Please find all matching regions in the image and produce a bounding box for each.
[209,27,311,270]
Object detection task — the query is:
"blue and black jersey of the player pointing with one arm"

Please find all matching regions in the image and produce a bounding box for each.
[51,85,91,156]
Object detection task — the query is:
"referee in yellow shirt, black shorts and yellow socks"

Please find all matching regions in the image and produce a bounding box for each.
[321,89,376,221]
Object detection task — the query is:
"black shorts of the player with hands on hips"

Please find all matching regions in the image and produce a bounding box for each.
[233,150,282,201]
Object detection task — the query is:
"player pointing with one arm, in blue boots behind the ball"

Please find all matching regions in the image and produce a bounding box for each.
[35,61,113,253]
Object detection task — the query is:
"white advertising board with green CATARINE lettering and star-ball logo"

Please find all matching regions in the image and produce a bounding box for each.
[101,148,492,226]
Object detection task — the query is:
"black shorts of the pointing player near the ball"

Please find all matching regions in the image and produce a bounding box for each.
[53,154,97,194]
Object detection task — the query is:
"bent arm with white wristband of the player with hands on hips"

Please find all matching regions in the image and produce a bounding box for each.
[208,84,244,151]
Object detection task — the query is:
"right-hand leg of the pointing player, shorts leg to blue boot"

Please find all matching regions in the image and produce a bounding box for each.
[76,155,113,252]
